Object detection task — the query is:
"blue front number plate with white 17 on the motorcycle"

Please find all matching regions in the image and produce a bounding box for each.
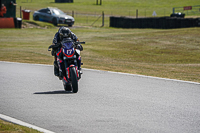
[63,42,75,57]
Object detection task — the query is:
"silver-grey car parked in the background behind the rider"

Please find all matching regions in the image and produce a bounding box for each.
[33,7,75,27]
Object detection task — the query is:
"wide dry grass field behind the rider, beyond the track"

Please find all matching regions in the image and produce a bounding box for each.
[0,27,200,82]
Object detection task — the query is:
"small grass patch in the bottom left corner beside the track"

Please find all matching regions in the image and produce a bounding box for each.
[0,119,40,133]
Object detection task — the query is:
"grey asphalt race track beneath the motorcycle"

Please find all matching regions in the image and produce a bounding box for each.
[0,61,200,133]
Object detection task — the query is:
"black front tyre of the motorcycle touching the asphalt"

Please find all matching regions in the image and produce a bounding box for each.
[70,67,78,93]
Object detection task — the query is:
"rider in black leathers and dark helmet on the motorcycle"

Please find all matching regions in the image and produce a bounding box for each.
[52,26,83,77]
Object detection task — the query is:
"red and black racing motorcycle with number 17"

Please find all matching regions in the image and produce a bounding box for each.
[48,38,85,93]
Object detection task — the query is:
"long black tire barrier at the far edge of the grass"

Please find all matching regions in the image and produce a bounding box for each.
[110,16,200,29]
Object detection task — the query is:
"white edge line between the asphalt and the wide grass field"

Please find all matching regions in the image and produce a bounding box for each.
[0,61,200,85]
